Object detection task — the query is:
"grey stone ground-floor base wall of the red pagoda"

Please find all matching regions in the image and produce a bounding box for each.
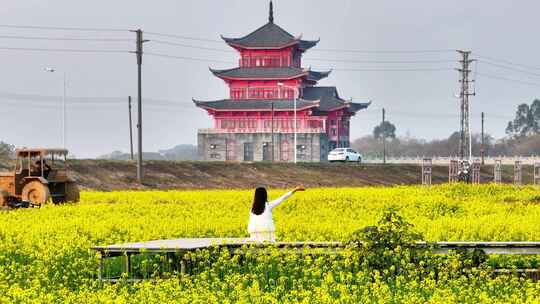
[198,130,328,162]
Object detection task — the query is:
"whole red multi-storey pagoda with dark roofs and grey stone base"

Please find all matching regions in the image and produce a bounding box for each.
[193,1,370,162]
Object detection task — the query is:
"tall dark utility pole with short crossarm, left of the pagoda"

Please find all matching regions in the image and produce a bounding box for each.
[132,29,149,184]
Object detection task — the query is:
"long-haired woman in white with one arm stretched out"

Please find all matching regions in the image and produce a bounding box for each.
[248,187,304,242]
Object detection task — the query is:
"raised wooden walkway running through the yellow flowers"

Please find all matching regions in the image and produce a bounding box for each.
[92,238,540,281]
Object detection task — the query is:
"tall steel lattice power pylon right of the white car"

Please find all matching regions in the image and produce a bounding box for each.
[456,50,475,163]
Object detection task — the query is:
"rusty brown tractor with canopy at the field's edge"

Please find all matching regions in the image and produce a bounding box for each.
[0,149,79,208]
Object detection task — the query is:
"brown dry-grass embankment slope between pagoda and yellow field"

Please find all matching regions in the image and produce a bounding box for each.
[53,160,532,191]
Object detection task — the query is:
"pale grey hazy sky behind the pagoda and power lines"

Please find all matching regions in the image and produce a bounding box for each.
[0,0,540,157]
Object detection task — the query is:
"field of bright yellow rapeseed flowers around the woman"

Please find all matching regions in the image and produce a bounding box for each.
[0,185,540,303]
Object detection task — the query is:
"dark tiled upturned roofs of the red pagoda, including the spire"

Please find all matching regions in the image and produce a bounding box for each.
[194,3,370,115]
